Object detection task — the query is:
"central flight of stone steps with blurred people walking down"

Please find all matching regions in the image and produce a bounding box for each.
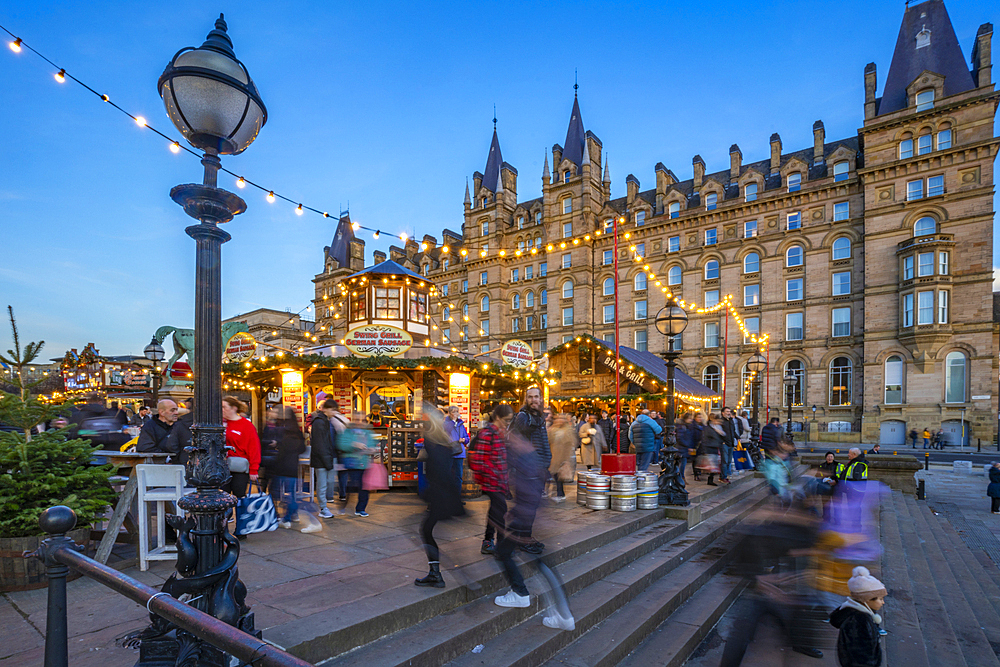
[319,468,780,667]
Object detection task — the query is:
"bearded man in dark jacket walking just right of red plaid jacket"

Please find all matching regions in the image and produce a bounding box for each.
[512,387,552,554]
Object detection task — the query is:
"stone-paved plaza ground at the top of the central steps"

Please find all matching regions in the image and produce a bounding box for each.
[0,468,748,667]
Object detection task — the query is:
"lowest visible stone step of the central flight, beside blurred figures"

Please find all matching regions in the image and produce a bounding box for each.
[618,573,747,667]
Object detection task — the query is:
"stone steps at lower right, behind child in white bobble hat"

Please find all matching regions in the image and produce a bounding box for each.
[881,491,1000,667]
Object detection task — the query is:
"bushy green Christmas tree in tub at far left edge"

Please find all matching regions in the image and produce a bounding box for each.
[0,306,115,592]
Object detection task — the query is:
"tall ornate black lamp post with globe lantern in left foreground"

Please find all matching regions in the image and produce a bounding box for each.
[138,15,267,667]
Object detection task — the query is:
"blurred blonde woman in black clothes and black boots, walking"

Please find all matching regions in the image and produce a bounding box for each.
[413,403,465,588]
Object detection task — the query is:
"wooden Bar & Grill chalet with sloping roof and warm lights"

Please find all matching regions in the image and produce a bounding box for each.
[547,335,719,426]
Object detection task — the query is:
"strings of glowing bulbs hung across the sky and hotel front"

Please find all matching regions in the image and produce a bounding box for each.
[0,25,768,407]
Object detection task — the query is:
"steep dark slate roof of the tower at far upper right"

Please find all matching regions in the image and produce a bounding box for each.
[878,0,975,115]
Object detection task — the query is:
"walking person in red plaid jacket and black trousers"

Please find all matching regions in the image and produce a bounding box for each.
[469,403,514,555]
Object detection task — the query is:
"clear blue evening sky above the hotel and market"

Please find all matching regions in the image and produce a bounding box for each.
[0,0,1000,358]
